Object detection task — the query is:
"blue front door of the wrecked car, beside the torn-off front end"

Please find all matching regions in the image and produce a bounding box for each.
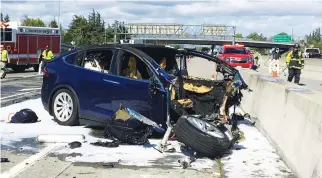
[112,50,167,124]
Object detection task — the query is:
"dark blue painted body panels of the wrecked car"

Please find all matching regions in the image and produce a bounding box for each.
[41,46,166,127]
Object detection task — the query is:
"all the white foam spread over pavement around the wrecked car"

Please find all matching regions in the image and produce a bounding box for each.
[0,99,289,175]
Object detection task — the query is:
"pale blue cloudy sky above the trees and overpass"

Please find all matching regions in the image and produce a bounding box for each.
[1,0,322,37]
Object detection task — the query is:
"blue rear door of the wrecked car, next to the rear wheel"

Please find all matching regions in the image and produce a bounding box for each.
[71,48,117,122]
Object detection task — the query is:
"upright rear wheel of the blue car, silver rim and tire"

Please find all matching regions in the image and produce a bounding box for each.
[51,89,79,126]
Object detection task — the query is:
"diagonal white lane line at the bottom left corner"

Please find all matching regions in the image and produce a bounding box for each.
[1,144,62,178]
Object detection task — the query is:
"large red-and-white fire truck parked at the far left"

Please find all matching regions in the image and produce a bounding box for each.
[1,22,61,72]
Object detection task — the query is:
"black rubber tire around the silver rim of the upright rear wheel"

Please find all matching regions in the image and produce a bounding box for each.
[50,89,79,126]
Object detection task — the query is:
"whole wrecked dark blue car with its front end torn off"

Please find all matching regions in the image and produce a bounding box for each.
[41,44,248,157]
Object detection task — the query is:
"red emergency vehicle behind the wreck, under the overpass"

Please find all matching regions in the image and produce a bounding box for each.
[217,45,254,68]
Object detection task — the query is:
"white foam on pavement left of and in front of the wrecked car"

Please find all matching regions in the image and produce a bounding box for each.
[0,99,215,169]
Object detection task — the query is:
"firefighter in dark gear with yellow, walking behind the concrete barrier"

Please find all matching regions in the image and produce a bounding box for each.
[286,43,304,84]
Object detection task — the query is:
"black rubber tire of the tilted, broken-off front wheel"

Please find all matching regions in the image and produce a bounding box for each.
[174,116,231,158]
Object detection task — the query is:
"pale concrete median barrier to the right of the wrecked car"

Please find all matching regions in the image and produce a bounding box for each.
[241,70,322,178]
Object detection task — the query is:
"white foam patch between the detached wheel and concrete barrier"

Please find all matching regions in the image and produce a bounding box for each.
[222,107,292,178]
